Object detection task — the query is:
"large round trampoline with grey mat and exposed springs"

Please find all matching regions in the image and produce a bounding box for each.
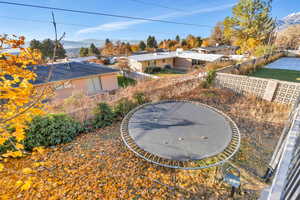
[121,100,240,169]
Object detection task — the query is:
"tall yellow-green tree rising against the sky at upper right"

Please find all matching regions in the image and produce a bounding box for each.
[223,0,275,54]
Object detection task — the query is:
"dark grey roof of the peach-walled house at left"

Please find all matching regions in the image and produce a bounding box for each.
[29,62,119,84]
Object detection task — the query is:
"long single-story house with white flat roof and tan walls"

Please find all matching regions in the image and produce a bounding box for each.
[128,50,240,72]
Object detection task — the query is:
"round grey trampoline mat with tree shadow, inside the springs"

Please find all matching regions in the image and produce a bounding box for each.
[128,101,232,161]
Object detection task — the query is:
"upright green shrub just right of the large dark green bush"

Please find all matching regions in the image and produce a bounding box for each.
[93,103,116,128]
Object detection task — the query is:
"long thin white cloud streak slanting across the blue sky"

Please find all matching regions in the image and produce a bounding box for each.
[77,4,235,34]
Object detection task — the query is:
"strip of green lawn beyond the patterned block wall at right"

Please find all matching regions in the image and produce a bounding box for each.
[250,68,300,83]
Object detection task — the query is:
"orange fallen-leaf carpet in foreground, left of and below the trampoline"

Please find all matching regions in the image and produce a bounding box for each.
[0,124,234,199]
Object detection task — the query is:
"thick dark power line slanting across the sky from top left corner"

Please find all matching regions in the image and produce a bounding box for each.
[0,1,211,27]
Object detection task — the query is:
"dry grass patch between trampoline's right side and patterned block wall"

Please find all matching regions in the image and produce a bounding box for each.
[173,88,290,177]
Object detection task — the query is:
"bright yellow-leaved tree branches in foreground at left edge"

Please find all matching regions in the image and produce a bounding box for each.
[0,35,47,159]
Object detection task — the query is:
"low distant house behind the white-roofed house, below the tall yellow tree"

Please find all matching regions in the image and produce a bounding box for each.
[192,45,239,55]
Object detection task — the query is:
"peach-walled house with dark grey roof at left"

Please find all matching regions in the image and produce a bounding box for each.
[31,62,119,99]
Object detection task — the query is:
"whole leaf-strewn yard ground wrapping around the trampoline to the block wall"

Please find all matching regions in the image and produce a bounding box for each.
[0,88,289,199]
